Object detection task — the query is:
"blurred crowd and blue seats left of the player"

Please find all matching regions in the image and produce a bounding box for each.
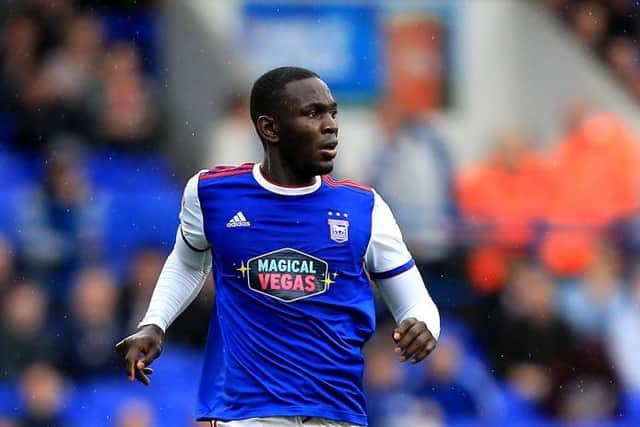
[0,0,205,427]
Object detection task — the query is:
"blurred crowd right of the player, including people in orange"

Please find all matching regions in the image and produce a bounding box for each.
[360,101,640,427]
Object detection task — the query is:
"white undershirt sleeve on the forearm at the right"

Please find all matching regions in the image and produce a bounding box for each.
[376,266,440,340]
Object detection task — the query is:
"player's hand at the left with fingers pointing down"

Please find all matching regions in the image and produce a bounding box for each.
[116,325,164,385]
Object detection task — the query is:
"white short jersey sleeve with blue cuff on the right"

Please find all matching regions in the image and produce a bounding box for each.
[365,191,415,279]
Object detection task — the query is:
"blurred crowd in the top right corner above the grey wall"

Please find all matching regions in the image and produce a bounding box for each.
[543,0,640,99]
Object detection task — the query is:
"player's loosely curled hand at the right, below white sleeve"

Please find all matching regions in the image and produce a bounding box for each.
[393,317,436,363]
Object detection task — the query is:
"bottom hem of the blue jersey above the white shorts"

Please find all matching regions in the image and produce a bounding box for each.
[196,406,367,427]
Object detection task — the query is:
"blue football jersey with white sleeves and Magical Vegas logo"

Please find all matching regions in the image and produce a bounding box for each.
[181,164,413,425]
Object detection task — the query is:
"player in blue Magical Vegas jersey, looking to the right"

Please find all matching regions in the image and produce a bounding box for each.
[116,67,440,427]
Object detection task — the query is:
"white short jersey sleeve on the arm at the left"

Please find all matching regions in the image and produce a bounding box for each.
[180,171,210,252]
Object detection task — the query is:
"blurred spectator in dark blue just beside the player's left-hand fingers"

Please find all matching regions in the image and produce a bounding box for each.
[64,267,122,379]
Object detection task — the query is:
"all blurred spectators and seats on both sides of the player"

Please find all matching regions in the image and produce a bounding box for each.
[0,0,640,427]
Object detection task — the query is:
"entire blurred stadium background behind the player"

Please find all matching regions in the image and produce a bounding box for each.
[0,0,640,427]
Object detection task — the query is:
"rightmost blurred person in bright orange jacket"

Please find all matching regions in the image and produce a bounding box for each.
[538,113,640,276]
